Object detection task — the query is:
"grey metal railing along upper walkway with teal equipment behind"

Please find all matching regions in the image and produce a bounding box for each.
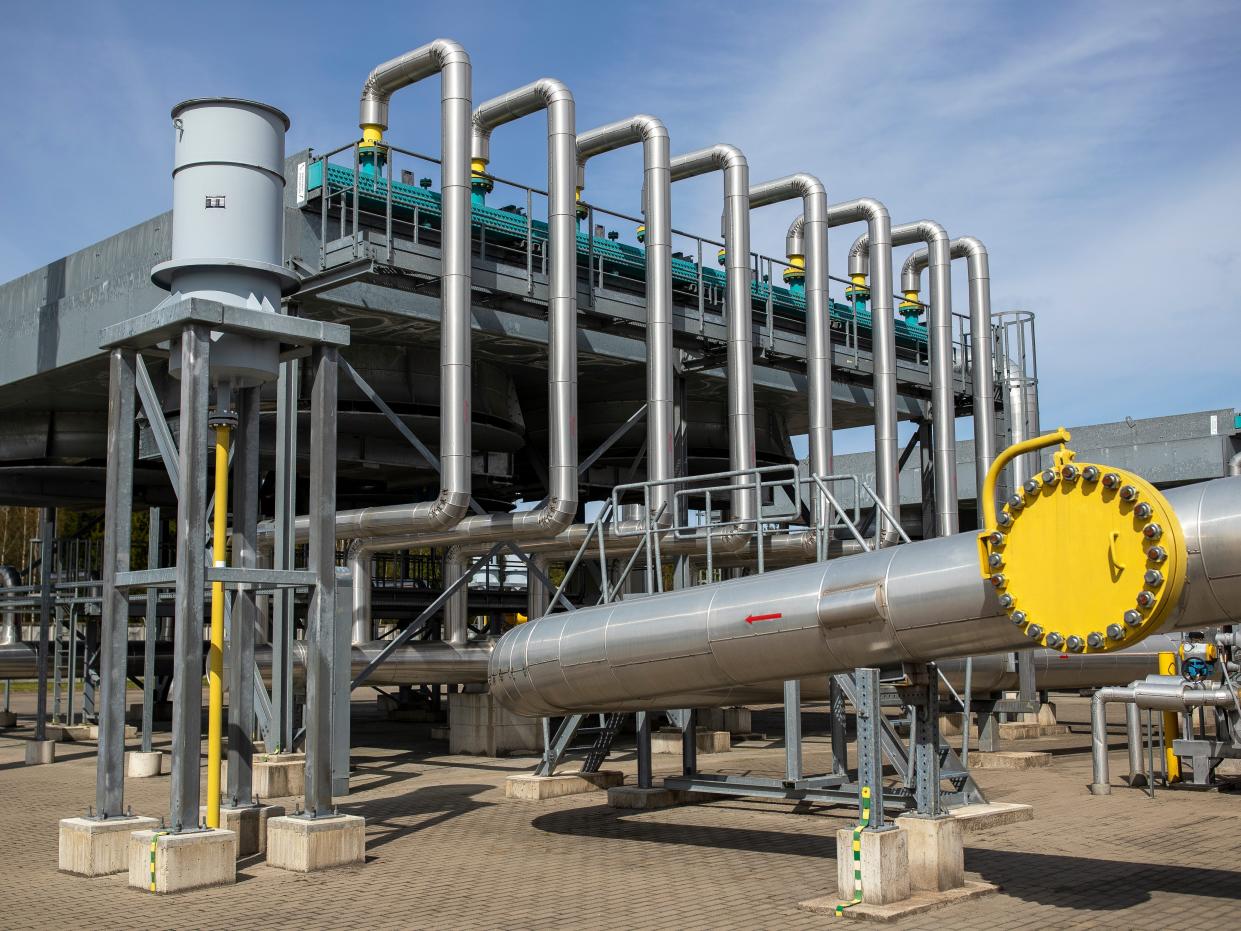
[298,143,938,369]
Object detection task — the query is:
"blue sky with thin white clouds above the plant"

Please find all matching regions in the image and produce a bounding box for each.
[0,0,1241,448]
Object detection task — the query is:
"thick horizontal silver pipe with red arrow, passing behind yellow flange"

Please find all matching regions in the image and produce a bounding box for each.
[488,478,1241,715]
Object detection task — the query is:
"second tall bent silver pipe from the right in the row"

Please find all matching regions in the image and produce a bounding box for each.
[849,220,958,536]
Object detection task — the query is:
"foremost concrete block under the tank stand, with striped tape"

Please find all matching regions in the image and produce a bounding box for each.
[129,829,237,894]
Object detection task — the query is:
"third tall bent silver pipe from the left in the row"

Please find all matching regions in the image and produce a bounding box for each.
[577,113,675,524]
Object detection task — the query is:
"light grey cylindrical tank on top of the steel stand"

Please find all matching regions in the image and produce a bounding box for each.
[151,97,298,387]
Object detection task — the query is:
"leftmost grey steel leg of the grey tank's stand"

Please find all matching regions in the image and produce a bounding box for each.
[96,349,135,818]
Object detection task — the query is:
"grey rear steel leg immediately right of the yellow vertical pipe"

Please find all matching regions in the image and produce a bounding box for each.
[225,387,262,808]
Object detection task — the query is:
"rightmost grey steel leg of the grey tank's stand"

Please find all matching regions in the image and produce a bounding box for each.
[305,346,339,818]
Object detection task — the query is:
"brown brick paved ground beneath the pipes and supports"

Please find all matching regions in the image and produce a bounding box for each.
[0,695,1241,931]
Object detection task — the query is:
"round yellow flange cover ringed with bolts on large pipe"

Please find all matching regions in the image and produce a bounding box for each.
[979,446,1188,653]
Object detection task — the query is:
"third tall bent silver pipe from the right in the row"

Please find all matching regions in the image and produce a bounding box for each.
[784,197,901,546]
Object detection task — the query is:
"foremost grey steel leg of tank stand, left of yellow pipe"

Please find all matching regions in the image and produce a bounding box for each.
[169,324,209,832]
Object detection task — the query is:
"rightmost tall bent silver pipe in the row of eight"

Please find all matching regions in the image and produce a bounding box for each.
[901,236,997,506]
